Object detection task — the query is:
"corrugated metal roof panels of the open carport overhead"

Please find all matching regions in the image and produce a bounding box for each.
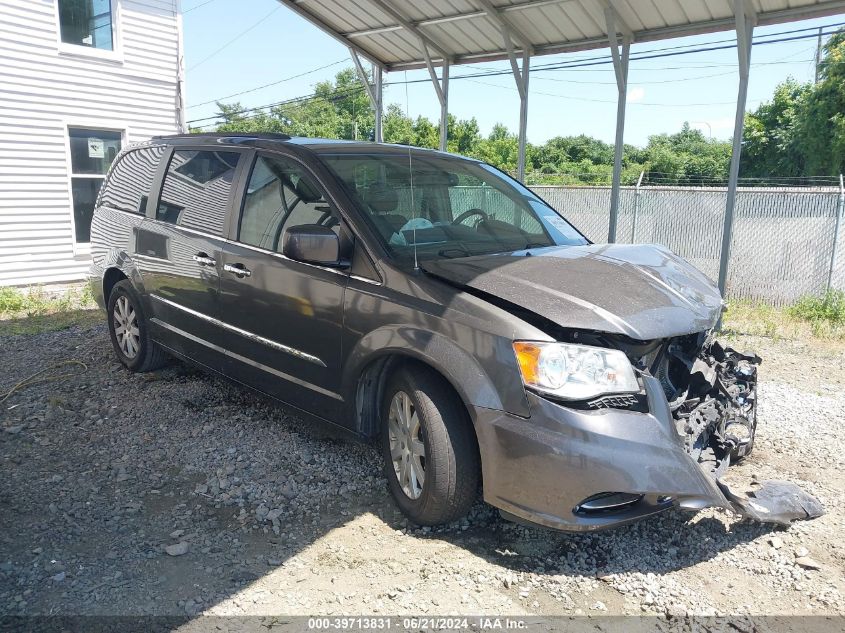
[279,0,845,70]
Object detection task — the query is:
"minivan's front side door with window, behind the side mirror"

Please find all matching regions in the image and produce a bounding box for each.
[220,153,347,419]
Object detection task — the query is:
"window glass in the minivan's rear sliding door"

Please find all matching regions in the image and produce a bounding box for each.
[156,150,240,235]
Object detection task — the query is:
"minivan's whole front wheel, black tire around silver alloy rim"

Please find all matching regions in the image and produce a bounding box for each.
[381,364,480,526]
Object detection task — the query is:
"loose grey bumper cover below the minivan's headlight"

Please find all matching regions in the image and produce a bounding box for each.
[474,377,730,530]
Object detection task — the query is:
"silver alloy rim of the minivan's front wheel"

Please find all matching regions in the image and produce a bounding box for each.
[387,391,425,499]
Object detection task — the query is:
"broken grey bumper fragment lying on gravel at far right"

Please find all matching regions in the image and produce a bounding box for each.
[716,480,824,525]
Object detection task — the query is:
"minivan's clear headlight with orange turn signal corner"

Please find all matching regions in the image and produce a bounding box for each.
[513,341,640,400]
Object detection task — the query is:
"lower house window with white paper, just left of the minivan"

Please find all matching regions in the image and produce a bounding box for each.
[68,128,122,244]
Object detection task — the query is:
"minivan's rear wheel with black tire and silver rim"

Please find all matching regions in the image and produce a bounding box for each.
[108,279,168,372]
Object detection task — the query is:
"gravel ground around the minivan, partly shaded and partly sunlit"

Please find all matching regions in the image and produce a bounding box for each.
[0,318,845,617]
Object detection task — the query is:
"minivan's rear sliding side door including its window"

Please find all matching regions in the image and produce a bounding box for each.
[135,148,241,371]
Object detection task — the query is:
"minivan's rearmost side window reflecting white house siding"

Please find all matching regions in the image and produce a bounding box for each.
[100,145,164,215]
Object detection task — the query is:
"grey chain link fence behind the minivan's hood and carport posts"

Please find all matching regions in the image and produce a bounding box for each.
[532,185,845,305]
